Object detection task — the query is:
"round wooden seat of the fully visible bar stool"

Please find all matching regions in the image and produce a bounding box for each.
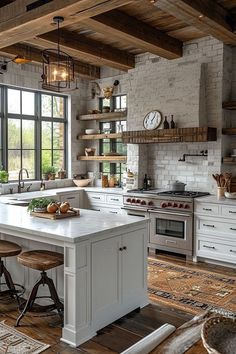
[17,250,64,271]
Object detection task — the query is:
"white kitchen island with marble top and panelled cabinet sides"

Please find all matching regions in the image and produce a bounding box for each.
[0,204,148,346]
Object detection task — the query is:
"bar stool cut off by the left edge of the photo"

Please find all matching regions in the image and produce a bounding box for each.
[0,240,25,303]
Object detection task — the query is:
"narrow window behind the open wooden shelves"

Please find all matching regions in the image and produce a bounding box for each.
[99,95,127,183]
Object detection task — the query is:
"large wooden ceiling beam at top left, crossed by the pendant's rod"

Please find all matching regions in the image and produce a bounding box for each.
[0,0,134,48]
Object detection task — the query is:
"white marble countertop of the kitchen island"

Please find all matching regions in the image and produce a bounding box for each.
[0,204,148,243]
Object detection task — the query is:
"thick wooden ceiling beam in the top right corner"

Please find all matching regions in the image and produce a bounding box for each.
[155,0,236,44]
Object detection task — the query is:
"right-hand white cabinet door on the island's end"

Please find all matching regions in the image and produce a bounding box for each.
[121,231,147,306]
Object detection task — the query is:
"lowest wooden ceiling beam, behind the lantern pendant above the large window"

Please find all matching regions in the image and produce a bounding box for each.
[0,44,100,80]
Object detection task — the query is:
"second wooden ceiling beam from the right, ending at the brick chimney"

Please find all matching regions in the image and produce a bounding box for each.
[81,10,182,59]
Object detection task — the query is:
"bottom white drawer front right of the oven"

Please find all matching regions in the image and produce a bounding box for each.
[197,239,236,263]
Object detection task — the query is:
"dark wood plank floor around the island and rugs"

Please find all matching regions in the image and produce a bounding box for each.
[0,250,235,354]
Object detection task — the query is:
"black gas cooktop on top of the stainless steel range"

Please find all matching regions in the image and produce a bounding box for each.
[127,188,210,198]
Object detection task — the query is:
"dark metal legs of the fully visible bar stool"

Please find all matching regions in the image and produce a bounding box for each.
[16,271,64,327]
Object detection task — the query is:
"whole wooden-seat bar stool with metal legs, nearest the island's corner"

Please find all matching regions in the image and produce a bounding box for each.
[16,250,64,327]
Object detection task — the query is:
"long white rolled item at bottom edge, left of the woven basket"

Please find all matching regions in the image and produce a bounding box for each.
[121,323,176,354]
